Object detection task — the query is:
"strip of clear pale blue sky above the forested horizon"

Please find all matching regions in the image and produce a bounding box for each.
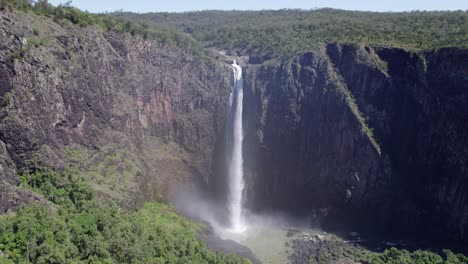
[49,0,468,13]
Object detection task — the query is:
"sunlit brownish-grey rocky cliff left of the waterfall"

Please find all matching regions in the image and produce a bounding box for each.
[0,10,232,212]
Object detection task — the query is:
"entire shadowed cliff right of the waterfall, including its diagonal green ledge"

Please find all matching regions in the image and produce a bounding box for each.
[244,44,468,243]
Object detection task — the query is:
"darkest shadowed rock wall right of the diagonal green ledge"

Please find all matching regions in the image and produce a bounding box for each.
[328,46,468,239]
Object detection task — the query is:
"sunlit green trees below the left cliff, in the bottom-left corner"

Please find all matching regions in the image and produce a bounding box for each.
[0,170,249,263]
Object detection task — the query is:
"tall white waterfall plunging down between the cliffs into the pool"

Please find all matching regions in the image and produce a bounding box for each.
[226,60,245,233]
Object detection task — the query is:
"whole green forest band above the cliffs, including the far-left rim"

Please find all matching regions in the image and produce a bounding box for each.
[0,0,468,57]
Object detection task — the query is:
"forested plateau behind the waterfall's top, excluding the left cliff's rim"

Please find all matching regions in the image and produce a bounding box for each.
[113,9,468,57]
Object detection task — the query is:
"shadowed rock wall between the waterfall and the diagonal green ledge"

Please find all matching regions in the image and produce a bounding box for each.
[245,49,388,229]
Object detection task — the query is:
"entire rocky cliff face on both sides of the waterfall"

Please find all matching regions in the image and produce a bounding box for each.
[0,11,468,245]
